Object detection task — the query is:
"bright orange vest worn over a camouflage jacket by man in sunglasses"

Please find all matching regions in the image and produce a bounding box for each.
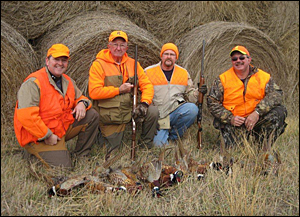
[220,68,270,117]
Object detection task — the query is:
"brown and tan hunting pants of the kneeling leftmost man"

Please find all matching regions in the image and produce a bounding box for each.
[24,108,99,168]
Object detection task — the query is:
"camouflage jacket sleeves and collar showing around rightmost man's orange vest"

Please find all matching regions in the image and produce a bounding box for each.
[207,66,283,124]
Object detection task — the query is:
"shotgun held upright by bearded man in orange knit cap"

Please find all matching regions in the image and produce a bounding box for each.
[197,40,205,149]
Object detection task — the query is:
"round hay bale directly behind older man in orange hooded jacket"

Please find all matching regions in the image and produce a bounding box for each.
[39,12,161,95]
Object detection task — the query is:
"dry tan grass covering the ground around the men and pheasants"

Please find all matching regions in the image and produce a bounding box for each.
[1,113,299,216]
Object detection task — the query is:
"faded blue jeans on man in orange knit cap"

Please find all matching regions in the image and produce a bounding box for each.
[153,103,198,147]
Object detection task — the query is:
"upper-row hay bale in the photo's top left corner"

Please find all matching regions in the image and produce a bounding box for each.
[1,1,110,39]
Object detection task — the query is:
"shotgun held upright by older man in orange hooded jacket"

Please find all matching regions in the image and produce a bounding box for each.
[131,45,138,161]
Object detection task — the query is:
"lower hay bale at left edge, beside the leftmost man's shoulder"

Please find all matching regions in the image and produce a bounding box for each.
[1,20,38,126]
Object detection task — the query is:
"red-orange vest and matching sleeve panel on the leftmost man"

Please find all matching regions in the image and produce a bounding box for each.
[14,67,75,147]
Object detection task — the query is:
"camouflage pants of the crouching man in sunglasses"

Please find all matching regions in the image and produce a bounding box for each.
[213,105,287,149]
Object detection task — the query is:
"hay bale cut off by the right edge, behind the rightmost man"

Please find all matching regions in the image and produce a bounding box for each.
[265,1,299,103]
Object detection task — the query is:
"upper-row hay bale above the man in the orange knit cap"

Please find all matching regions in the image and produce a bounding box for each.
[147,1,273,42]
